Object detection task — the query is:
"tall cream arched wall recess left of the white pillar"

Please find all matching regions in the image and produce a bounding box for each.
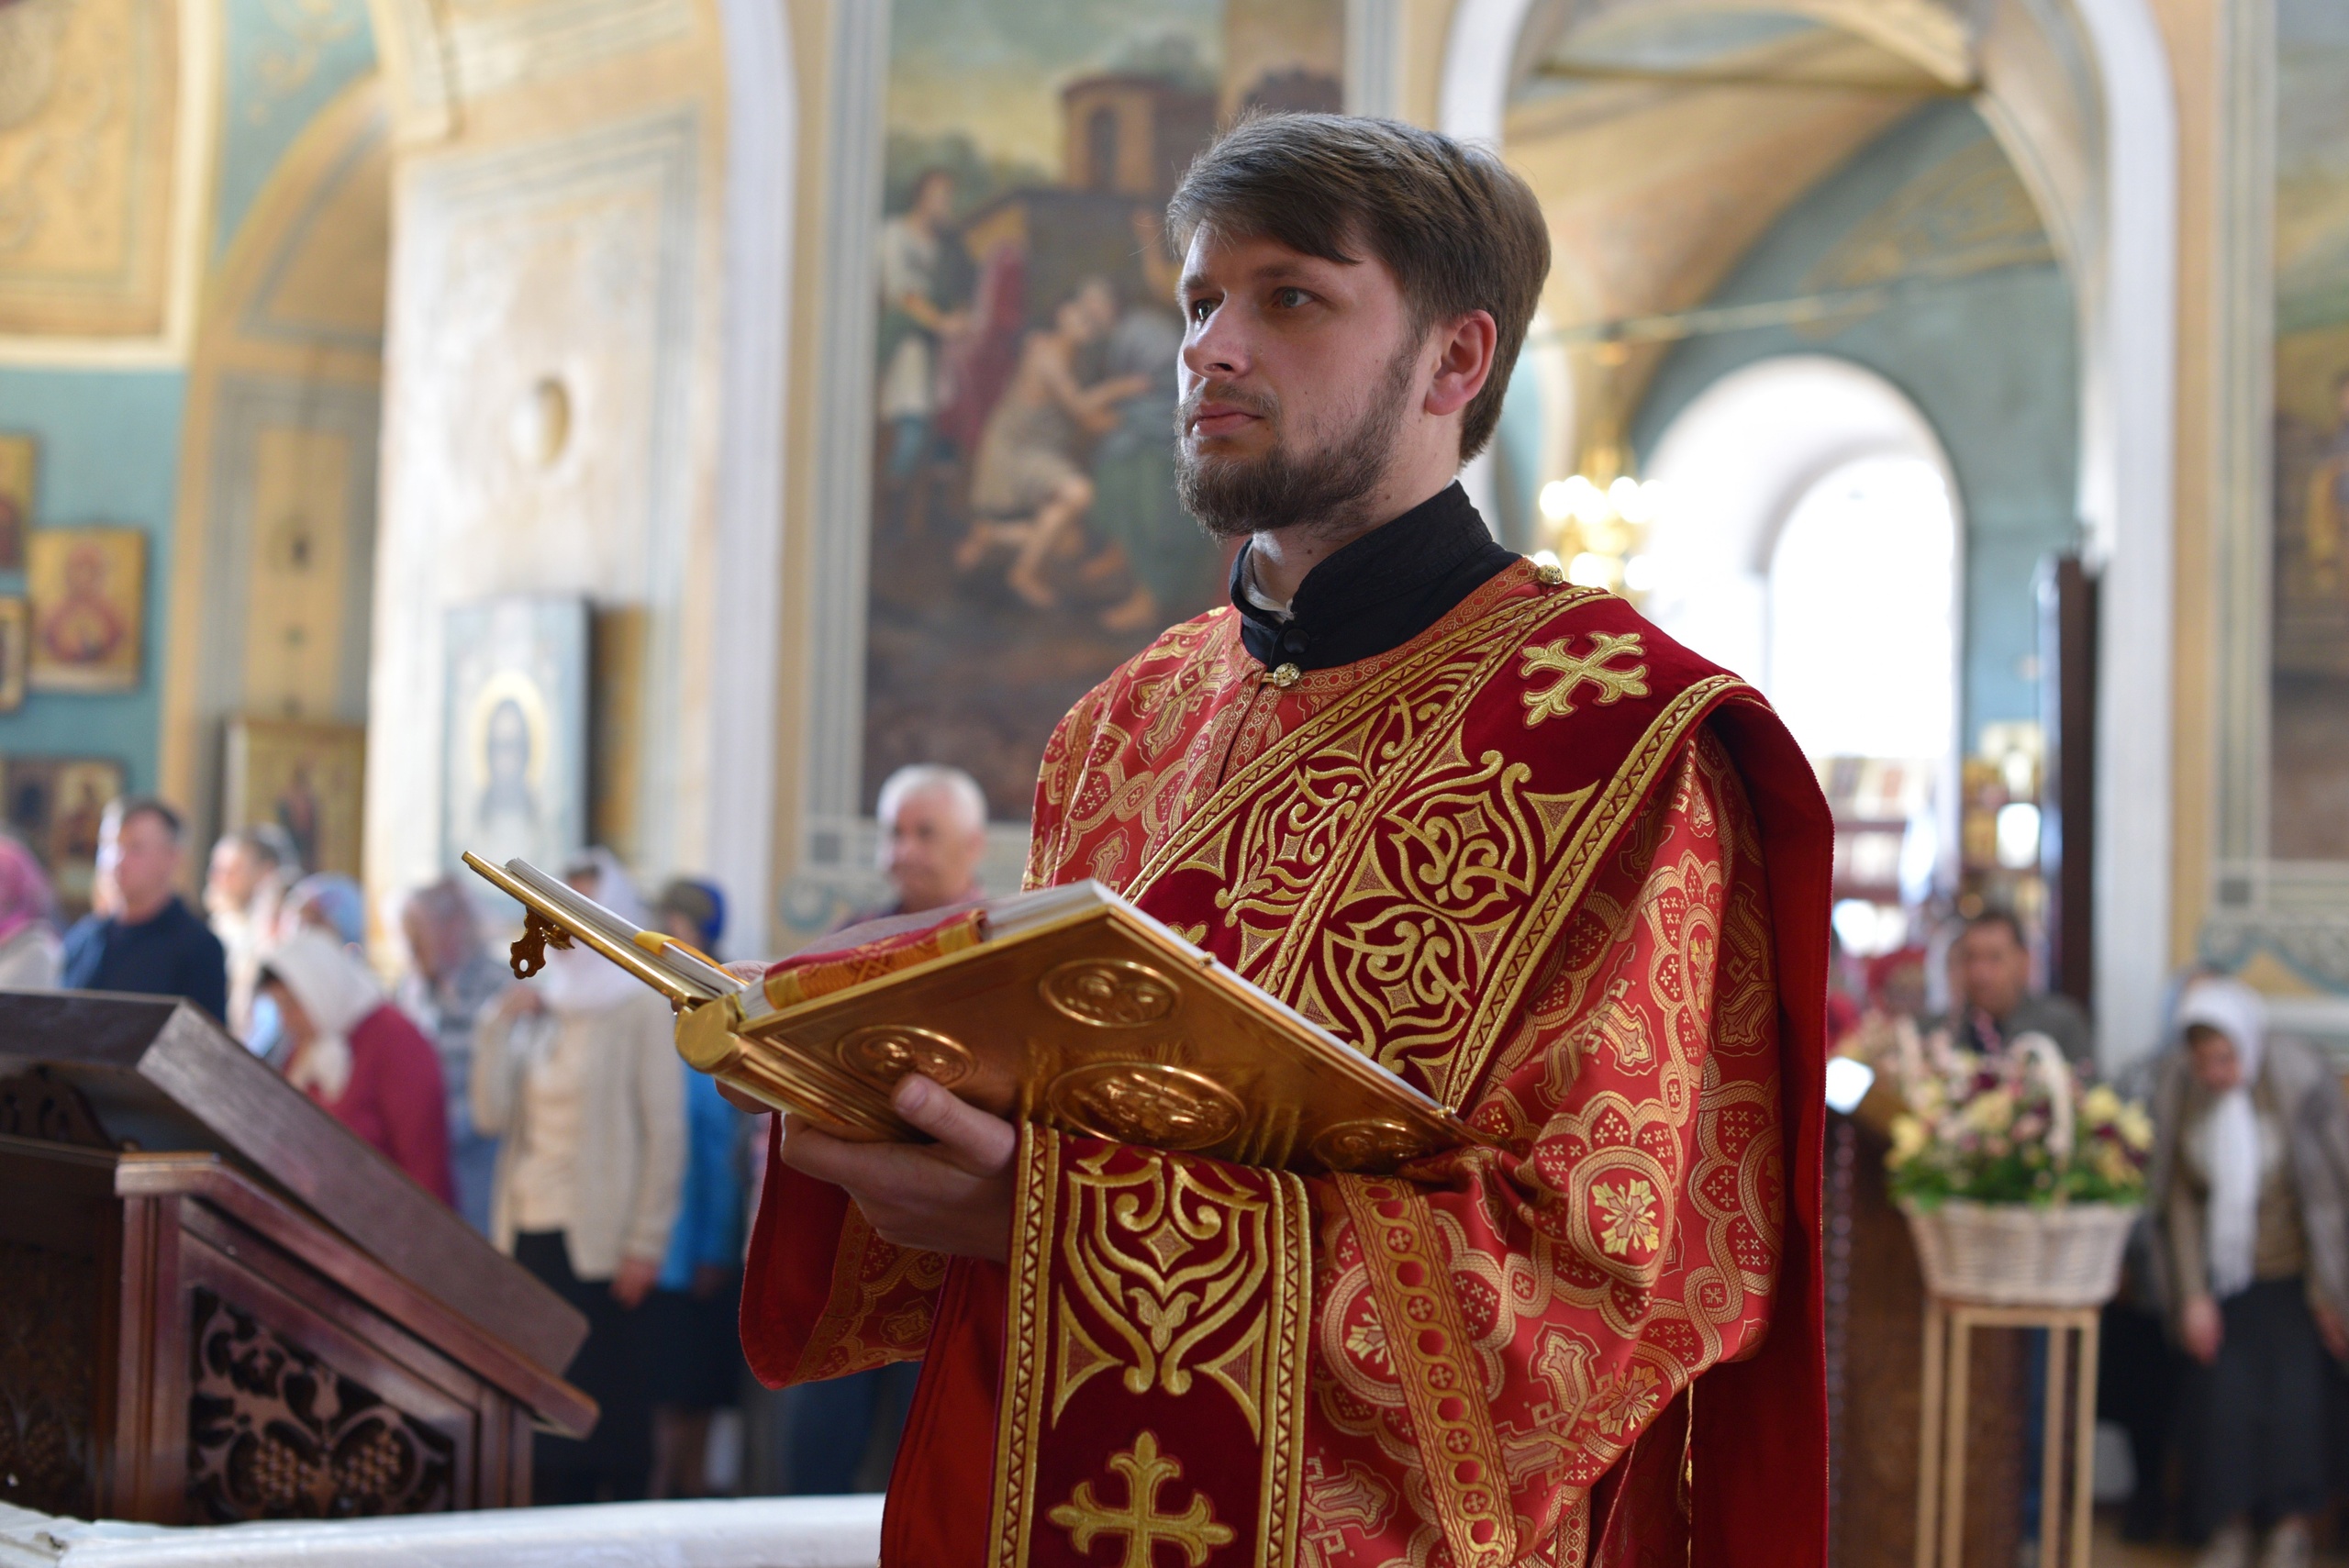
[158,72,390,875]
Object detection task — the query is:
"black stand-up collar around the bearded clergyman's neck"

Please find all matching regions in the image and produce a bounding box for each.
[1230,481,1518,672]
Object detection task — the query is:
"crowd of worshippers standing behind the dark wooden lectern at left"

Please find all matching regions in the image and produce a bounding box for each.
[0,765,986,1502]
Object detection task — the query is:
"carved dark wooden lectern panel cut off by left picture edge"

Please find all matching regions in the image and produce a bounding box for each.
[0,1241,99,1518]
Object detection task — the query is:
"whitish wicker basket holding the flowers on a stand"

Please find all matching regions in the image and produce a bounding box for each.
[1900,1199,2138,1307]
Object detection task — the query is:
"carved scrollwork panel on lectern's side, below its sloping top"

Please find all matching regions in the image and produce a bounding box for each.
[188,1289,456,1523]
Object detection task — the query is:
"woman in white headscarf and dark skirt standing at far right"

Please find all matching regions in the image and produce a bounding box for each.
[2152,979,2349,1568]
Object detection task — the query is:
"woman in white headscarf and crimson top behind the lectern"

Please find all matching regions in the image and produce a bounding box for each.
[256,928,456,1209]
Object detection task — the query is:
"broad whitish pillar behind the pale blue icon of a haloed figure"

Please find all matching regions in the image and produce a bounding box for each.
[366,0,726,943]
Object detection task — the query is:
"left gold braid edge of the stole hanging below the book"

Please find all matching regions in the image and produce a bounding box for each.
[986,1122,1060,1568]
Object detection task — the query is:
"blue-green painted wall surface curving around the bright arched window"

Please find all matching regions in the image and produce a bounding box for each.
[1631,104,2079,749]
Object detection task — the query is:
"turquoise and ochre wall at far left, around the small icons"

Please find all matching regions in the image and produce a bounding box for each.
[0,0,371,882]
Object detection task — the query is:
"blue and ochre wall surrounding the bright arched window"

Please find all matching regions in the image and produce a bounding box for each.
[1631,104,2081,751]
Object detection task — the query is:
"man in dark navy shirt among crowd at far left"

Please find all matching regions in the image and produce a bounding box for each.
[59,795,228,1018]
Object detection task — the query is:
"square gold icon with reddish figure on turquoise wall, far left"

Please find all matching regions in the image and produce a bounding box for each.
[26,528,146,693]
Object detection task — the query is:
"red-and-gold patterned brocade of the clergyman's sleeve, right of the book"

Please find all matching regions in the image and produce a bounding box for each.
[1308,735,1783,1563]
